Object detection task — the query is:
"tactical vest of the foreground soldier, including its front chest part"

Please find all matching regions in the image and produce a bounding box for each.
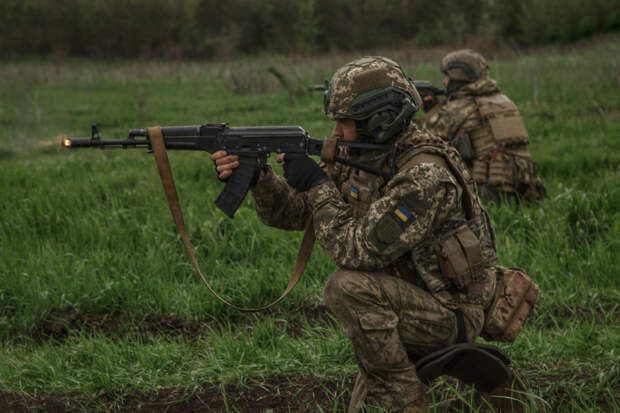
[332,134,497,308]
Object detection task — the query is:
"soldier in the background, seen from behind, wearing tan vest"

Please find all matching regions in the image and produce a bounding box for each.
[422,49,546,202]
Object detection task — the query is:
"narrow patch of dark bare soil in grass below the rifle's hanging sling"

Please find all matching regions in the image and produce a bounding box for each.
[32,302,336,343]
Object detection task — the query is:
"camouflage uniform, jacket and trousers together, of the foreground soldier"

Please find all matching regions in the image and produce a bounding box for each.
[252,56,495,412]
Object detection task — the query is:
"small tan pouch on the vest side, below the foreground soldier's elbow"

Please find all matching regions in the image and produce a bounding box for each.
[439,225,484,290]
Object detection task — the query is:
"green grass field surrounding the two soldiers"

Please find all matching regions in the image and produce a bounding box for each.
[0,38,620,412]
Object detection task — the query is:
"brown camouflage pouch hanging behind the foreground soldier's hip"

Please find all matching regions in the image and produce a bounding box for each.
[482,266,539,341]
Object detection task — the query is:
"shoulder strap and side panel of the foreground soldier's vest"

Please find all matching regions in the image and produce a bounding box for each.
[398,138,497,307]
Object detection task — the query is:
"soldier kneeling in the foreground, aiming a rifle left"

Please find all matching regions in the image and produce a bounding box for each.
[212,57,520,412]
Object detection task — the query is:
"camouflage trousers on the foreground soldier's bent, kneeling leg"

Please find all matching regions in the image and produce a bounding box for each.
[323,269,477,413]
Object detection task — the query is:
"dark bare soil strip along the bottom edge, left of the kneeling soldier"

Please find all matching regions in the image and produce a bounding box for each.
[0,376,355,413]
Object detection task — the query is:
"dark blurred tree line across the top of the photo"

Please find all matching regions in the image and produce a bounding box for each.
[0,0,620,58]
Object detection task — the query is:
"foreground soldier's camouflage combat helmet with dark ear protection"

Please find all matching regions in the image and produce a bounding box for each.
[324,56,422,143]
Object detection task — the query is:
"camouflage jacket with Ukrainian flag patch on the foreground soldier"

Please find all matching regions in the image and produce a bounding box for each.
[252,124,495,304]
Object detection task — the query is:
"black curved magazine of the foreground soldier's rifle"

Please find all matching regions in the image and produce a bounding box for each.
[215,156,258,218]
